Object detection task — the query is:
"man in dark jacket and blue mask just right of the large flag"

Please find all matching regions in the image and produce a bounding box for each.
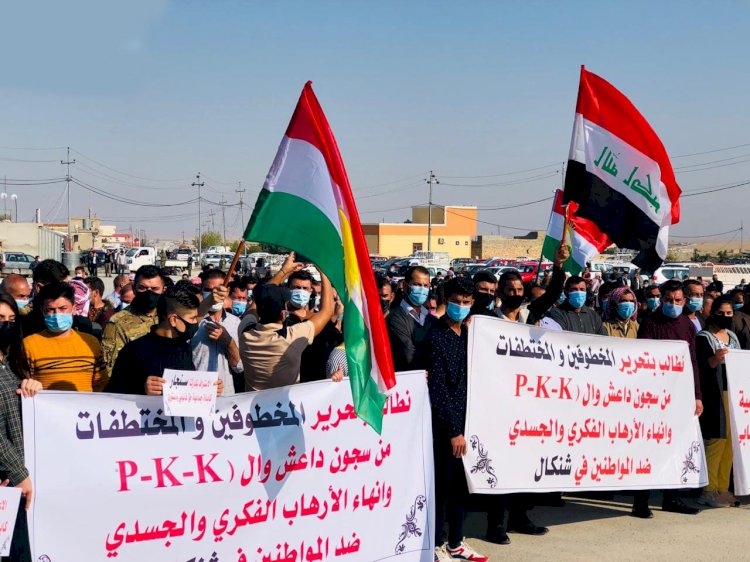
[386,265,437,372]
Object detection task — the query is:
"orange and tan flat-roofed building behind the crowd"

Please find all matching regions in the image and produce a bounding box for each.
[362,205,477,258]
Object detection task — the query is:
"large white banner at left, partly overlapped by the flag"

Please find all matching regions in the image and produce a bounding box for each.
[23,372,435,562]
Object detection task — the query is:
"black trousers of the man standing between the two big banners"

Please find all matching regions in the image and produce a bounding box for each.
[432,437,469,547]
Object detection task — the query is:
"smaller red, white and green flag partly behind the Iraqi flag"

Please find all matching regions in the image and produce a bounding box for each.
[542,189,611,275]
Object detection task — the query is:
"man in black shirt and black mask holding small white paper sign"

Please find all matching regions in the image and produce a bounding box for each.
[105,288,224,396]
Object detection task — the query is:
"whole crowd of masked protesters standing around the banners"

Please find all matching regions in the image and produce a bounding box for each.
[0,247,750,561]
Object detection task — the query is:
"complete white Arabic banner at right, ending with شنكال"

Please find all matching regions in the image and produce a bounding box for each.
[464,316,706,494]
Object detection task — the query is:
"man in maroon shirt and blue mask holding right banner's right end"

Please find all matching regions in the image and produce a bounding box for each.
[633,279,703,518]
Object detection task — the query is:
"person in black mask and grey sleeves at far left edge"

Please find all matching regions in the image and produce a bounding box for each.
[0,293,42,562]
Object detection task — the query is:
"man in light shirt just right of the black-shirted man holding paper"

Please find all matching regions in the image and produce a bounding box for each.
[190,269,241,396]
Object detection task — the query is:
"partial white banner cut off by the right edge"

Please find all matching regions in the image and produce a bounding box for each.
[724,349,750,496]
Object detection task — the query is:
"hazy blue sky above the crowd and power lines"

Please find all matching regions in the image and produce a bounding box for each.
[0,0,750,238]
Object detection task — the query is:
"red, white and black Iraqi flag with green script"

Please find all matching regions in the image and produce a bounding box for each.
[564,67,681,271]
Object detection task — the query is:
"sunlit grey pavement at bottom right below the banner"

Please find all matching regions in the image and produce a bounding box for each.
[464,494,750,562]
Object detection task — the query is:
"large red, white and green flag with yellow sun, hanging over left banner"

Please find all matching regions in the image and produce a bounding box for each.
[244,82,396,433]
